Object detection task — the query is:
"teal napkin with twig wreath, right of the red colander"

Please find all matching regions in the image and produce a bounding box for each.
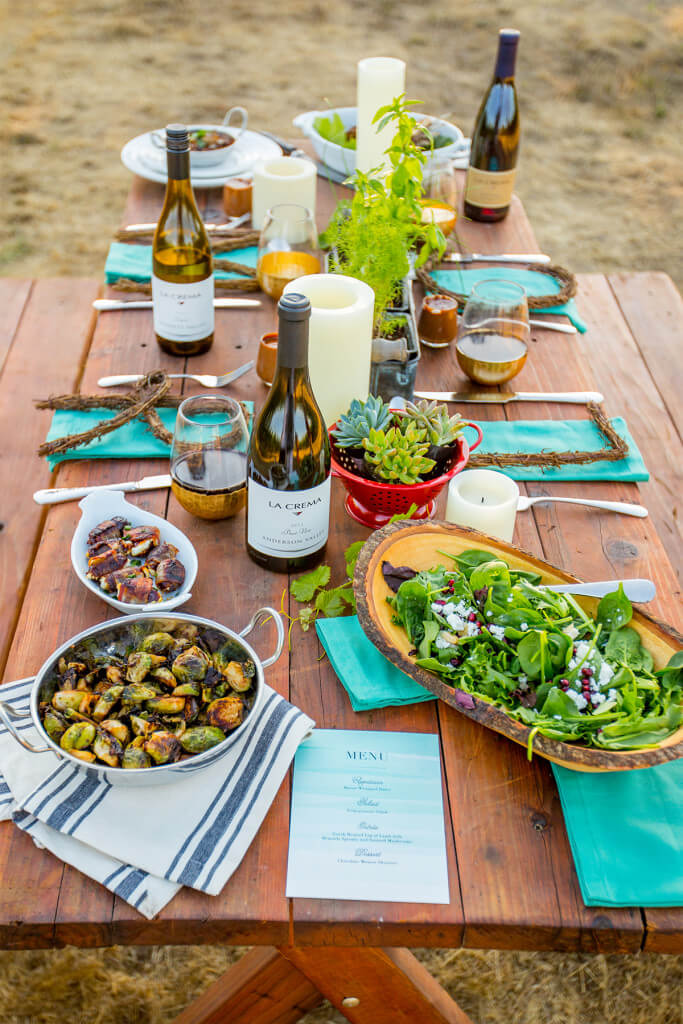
[468,416,649,481]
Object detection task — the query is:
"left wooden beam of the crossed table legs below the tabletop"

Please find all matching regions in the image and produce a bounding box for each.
[173,946,323,1024]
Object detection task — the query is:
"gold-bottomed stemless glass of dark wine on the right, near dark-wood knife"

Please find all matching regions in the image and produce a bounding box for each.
[456,279,529,384]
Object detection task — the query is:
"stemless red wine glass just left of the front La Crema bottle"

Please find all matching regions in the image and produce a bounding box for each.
[171,395,249,519]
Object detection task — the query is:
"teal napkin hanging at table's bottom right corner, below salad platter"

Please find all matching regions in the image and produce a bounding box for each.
[552,760,683,906]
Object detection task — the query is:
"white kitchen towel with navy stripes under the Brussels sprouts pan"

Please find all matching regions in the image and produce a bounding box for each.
[0,679,313,918]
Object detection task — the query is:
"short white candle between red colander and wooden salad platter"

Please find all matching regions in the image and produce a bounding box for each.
[445,469,519,541]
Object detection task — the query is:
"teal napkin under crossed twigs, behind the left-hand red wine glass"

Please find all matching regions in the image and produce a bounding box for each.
[46,401,254,469]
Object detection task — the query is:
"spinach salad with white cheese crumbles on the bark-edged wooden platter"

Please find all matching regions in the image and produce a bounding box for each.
[382,550,683,754]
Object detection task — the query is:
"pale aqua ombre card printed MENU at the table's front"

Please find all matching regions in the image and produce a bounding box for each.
[287,729,450,903]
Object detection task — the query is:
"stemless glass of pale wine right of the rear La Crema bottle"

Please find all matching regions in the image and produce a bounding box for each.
[256,203,322,301]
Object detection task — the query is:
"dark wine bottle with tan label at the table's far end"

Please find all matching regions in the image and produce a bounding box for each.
[465,29,519,222]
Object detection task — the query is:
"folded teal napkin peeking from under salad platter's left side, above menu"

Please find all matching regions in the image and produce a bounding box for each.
[315,615,436,711]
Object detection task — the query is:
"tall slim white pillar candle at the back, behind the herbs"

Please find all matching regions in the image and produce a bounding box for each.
[355,57,405,176]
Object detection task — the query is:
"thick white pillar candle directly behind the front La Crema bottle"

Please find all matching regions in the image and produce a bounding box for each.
[285,273,375,427]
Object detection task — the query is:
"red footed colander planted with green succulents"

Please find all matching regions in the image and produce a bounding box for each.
[330,395,481,529]
